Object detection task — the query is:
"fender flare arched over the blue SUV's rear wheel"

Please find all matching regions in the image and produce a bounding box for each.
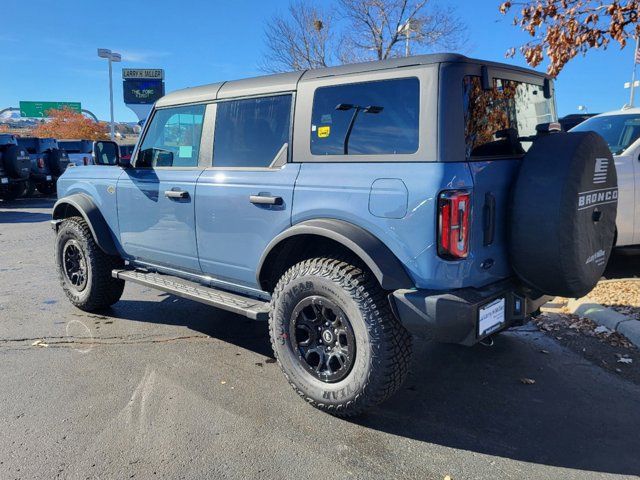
[256,218,414,290]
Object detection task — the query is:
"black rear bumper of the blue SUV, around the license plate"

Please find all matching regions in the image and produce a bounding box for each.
[391,280,551,345]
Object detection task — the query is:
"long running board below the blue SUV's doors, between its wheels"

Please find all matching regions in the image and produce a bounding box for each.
[111,270,269,320]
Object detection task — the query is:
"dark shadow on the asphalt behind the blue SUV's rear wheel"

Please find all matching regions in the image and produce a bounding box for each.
[355,333,640,478]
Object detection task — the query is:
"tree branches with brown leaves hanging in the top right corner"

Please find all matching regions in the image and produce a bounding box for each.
[500,0,640,76]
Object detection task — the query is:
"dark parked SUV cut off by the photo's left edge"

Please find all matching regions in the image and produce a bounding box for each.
[0,134,31,200]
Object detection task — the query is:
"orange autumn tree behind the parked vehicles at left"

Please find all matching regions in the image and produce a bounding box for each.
[33,107,109,140]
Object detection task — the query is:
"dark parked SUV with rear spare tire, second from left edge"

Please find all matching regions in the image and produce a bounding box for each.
[18,137,69,195]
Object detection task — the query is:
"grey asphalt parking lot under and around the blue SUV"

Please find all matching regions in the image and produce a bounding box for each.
[0,199,640,480]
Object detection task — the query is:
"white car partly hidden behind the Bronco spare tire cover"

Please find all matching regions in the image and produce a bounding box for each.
[571,108,640,247]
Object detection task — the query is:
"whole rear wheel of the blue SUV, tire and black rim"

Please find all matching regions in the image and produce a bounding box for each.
[269,258,412,417]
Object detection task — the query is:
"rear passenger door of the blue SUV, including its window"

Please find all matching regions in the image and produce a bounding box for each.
[196,93,300,287]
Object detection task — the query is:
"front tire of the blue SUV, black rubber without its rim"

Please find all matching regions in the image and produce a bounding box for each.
[55,217,124,312]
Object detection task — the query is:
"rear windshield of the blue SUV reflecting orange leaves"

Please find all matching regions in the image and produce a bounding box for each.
[464,76,557,158]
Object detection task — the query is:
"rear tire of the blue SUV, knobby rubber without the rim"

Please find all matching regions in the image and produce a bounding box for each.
[269,257,412,417]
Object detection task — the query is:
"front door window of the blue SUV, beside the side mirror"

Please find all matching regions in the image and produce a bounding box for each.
[136,105,205,168]
